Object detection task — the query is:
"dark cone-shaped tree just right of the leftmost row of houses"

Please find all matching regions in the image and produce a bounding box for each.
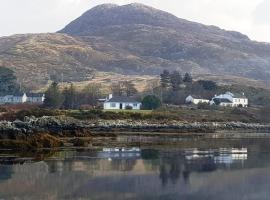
[44,82,64,108]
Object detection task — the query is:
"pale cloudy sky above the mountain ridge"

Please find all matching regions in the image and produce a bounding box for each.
[0,0,270,42]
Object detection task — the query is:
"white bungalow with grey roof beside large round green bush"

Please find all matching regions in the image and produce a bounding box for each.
[103,95,142,110]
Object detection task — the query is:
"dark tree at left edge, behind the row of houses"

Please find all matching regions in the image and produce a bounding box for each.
[0,67,20,94]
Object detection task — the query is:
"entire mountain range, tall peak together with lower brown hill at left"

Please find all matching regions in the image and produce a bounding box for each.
[0,3,270,89]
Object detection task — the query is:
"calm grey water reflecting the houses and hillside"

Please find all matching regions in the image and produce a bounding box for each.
[0,139,270,200]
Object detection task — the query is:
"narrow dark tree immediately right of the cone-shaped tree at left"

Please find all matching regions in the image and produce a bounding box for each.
[63,84,77,109]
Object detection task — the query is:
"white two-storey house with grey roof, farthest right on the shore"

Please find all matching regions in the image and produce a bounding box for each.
[210,92,248,107]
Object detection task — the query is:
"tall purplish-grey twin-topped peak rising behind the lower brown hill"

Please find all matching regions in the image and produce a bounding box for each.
[60,3,270,79]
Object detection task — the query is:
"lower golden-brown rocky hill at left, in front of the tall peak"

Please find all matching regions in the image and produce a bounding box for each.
[0,33,114,89]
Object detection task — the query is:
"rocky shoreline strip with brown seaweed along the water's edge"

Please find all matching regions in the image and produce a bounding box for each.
[0,117,270,148]
